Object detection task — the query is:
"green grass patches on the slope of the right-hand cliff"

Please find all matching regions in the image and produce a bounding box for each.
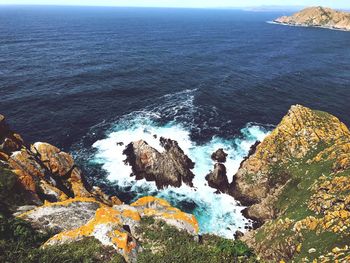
[255,139,350,262]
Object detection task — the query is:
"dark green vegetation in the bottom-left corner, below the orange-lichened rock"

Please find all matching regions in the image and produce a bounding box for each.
[0,212,125,263]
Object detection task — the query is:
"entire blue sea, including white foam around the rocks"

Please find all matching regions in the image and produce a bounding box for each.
[0,6,350,237]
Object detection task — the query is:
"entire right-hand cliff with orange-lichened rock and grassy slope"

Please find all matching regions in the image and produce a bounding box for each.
[230,105,350,262]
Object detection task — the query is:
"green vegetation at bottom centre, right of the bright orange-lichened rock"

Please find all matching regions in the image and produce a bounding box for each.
[137,218,257,263]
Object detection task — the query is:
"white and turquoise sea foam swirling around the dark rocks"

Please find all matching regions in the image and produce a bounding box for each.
[93,113,267,238]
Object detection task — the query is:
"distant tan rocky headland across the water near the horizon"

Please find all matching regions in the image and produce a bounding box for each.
[274,6,350,31]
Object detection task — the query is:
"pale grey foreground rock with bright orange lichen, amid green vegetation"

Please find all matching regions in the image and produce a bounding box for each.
[37,197,198,262]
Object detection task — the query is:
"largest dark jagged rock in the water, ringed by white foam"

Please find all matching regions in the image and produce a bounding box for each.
[123,137,194,189]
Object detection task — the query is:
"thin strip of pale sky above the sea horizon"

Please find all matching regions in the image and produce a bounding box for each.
[0,0,350,9]
